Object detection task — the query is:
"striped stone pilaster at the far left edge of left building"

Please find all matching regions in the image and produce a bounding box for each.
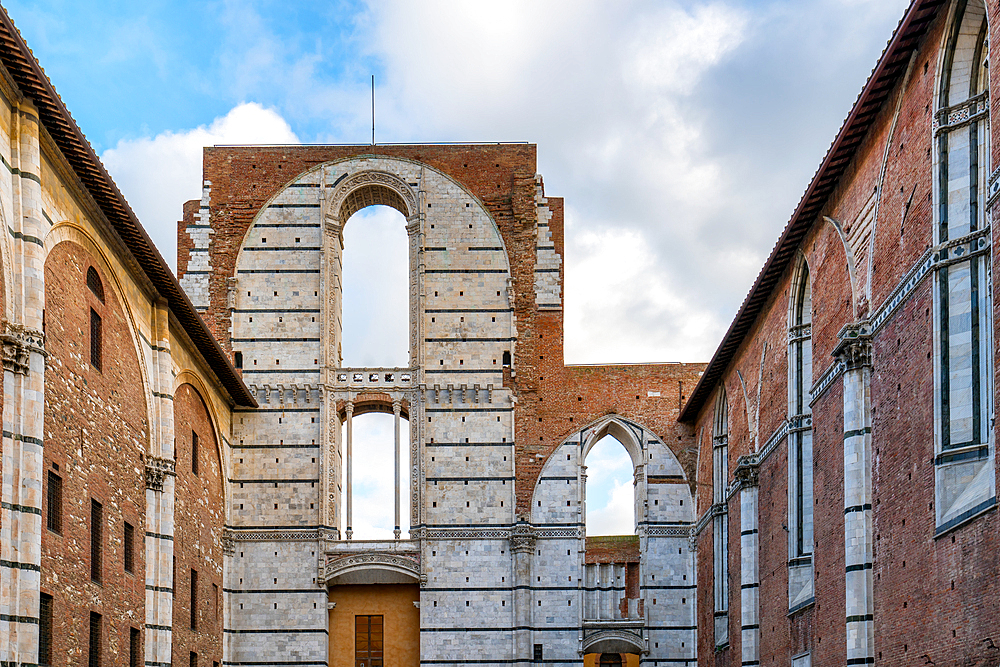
[0,100,46,664]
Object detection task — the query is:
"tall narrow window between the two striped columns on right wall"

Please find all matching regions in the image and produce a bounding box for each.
[788,260,814,609]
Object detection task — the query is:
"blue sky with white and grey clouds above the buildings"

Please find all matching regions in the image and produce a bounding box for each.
[4,0,908,532]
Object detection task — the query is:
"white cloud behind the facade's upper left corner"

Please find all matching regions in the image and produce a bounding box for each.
[101,102,299,271]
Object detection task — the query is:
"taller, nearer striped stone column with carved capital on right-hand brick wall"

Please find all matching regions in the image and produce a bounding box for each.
[834,327,875,665]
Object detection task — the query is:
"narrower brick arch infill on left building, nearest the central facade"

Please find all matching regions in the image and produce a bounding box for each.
[173,378,226,664]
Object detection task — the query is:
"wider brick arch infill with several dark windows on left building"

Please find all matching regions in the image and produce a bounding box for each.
[40,241,150,664]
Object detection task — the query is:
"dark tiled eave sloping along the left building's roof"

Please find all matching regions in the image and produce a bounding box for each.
[0,8,257,407]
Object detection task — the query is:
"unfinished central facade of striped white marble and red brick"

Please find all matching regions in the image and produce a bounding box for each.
[186,145,700,664]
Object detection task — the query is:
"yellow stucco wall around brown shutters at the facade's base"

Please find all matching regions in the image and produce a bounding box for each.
[330,584,420,667]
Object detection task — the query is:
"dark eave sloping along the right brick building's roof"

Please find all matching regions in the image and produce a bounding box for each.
[680,0,946,423]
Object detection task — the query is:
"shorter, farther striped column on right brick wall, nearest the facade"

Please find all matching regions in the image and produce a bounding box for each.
[733,455,760,665]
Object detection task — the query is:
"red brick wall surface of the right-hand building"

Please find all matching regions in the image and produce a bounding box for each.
[694,7,1000,665]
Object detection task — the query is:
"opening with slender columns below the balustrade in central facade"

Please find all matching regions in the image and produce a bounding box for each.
[341,412,410,540]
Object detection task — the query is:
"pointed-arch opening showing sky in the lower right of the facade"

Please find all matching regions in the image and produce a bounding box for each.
[584,434,635,537]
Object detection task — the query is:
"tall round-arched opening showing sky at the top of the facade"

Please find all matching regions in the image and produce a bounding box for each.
[335,205,410,368]
